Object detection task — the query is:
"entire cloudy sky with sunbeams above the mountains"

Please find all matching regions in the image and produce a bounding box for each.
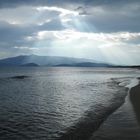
[0,0,140,65]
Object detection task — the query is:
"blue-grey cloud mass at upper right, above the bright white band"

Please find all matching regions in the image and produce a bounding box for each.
[70,2,140,33]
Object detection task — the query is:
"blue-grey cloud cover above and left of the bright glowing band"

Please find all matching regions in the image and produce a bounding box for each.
[0,0,140,64]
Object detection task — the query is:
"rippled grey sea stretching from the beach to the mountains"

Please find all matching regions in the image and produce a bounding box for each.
[0,67,140,140]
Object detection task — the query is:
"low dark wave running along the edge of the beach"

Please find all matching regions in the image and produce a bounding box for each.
[55,79,128,140]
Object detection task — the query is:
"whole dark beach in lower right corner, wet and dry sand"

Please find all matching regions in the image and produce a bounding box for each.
[90,78,140,140]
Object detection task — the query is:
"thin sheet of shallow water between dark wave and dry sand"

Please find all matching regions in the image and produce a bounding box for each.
[90,92,140,140]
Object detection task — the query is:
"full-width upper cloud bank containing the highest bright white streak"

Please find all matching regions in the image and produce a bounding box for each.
[0,0,140,32]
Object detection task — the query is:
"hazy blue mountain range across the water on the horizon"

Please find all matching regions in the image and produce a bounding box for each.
[0,55,109,67]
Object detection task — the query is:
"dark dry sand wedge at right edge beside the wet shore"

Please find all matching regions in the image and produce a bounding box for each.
[130,84,140,125]
